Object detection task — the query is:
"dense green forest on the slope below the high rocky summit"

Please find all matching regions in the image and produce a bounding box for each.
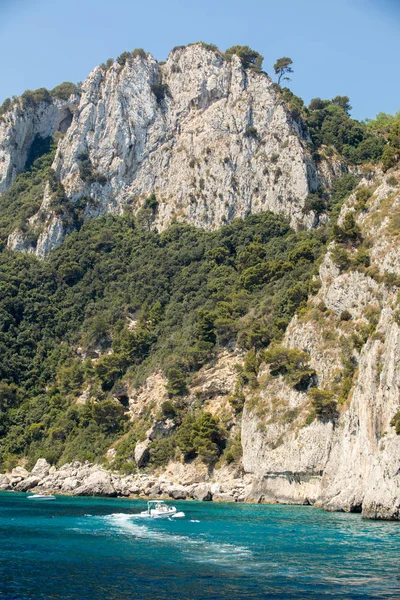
[0,206,324,469]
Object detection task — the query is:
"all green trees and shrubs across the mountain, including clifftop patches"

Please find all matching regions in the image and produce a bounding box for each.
[0,47,400,472]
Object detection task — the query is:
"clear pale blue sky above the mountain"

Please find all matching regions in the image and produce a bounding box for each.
[0,0,400,119]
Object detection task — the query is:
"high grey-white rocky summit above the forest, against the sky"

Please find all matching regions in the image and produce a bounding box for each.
[0,44,344,257]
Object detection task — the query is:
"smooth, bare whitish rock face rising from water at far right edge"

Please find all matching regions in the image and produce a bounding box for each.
[321,311,400,518]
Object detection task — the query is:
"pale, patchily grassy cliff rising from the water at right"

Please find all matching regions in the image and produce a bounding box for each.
[242,174,400,519]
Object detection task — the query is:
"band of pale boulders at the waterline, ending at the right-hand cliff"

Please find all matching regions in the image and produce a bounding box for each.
[0,458,250,502]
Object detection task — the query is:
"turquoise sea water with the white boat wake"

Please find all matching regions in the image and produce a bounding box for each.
[0,493,400,600]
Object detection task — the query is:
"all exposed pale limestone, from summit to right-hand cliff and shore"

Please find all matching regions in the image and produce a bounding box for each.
[0,44,400,519]
